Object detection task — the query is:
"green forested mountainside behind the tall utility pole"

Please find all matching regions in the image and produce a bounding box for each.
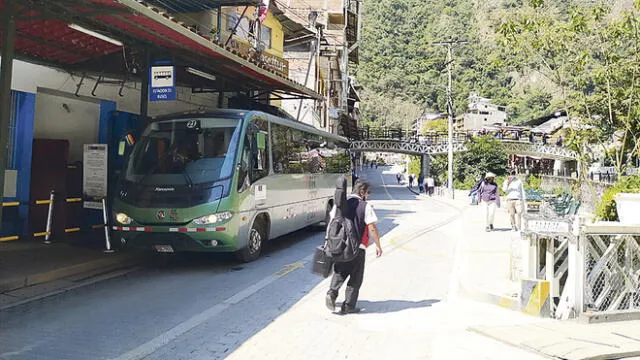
[357,0,634,126]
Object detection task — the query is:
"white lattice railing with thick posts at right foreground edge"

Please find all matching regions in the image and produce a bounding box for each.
[522,219,640,319]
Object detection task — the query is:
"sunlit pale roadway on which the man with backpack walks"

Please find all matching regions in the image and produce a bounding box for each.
[227,188,543,360]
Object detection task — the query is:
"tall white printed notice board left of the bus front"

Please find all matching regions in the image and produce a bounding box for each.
[82,144,108,209]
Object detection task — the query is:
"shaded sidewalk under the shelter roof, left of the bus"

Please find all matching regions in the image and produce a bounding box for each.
[0,241,138,309]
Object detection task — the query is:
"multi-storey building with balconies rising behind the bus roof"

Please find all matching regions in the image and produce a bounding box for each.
[278,0,361,137]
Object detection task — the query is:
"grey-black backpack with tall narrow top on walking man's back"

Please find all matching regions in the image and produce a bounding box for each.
[325,176,361,262]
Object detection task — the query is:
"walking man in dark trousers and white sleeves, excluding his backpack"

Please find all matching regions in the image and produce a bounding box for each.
[326,181,382,315]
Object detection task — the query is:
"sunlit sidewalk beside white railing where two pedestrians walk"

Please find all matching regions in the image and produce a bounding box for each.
[432,188,640,360]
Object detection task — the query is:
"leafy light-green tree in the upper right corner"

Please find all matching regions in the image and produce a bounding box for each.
[499,0,640,175]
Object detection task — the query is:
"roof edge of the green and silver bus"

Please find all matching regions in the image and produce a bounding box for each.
[152,109,349,142]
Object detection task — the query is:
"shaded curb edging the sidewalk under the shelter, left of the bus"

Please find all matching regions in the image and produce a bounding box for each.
[0,253,138,293]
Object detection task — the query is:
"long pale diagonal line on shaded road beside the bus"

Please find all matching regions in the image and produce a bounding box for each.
[115,255,313,360]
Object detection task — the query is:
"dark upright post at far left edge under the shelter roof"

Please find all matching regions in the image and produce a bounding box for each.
[0,0,16,233]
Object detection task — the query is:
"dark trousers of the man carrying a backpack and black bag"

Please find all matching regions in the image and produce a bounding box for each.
[328,249,367,308]
